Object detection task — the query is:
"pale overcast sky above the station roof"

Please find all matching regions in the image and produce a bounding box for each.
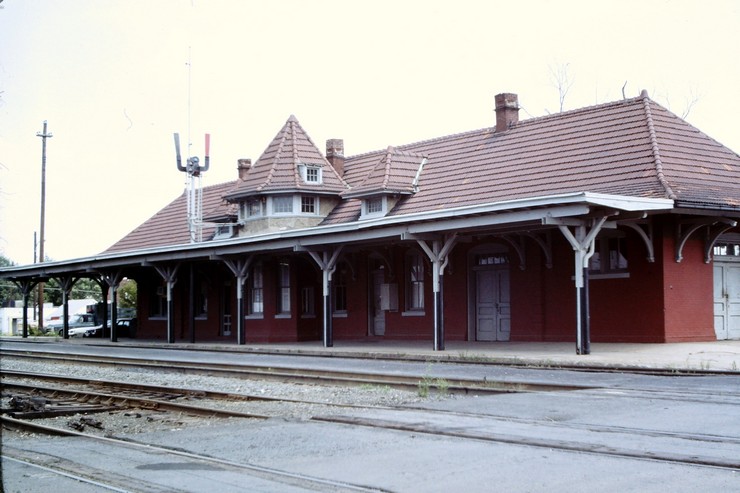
[0,0,740,264]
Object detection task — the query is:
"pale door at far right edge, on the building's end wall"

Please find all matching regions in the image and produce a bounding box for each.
[714,262,740,340]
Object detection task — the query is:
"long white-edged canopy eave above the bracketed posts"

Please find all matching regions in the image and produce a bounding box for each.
[0,192,674,279]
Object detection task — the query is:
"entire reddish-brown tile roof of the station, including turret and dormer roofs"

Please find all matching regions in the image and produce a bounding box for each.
[108,94,740,252]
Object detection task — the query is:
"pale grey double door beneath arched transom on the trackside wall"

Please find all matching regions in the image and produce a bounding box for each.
[475,269,511,341]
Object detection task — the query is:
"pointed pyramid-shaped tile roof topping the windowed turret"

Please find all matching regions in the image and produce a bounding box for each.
[226,115,348,200]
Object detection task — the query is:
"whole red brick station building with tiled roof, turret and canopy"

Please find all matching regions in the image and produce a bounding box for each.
[0,91,740,354]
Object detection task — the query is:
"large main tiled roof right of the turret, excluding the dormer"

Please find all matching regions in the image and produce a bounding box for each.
[324,95,740,224]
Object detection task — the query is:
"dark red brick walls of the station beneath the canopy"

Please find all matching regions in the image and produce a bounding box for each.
[136,218,715,342]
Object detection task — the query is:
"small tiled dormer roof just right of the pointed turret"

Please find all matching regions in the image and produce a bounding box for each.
[342,146,426,198]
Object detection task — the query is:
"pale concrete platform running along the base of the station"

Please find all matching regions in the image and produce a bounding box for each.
[5,337,740,374]
